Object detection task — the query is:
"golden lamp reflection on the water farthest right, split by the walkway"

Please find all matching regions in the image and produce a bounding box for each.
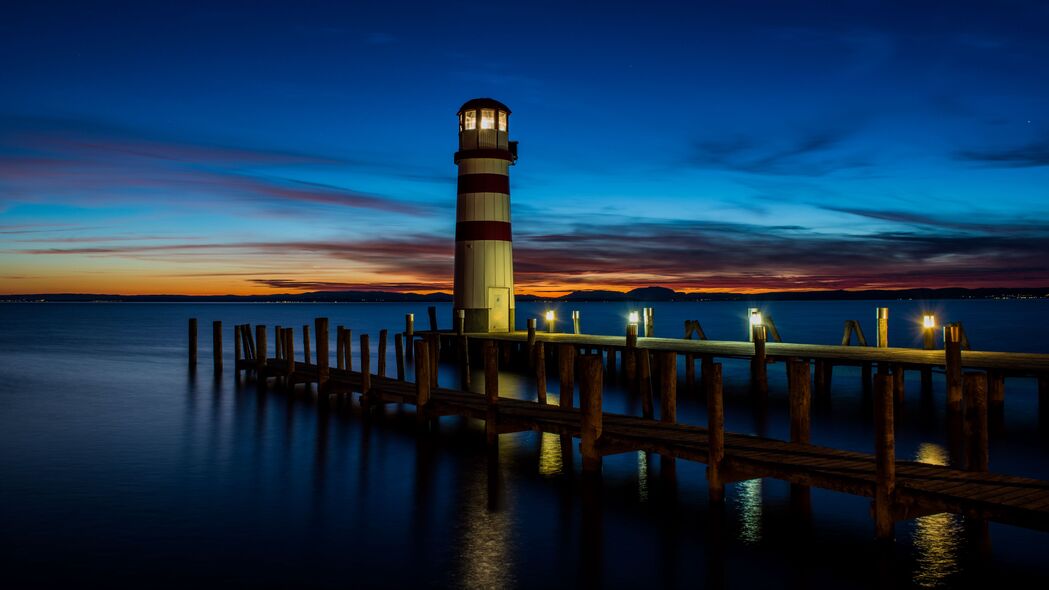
[914,443,965,587]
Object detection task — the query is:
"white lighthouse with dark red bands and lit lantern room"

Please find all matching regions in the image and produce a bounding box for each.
[452,99,517,332]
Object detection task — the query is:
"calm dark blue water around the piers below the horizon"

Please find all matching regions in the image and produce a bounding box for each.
[0,300,1049,588]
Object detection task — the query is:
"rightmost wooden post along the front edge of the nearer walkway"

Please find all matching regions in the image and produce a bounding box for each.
[874,375,896,541]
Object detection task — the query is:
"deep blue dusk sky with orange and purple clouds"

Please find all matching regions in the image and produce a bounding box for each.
[0,0,1049,295]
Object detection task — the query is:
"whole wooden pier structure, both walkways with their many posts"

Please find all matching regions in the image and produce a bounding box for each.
[190,317,1049,540]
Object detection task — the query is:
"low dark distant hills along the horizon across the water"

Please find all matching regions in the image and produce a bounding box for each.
[0,287,1049,303]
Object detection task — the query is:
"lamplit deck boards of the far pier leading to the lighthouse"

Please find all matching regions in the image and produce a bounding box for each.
[467,332,1049,375]
